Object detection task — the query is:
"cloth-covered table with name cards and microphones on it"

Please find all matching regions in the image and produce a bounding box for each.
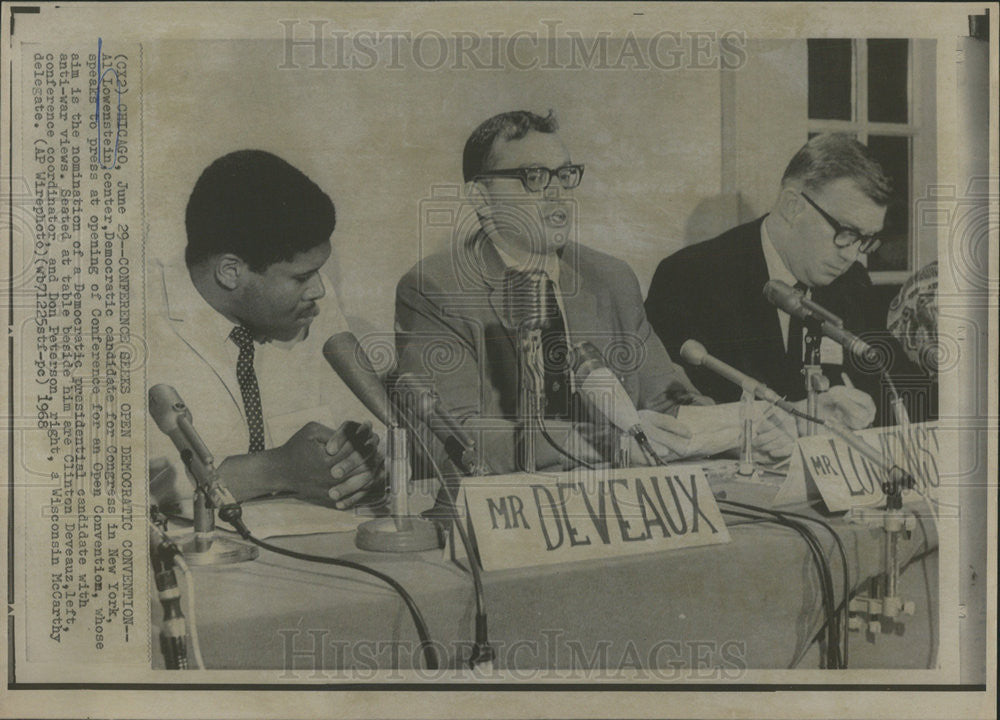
[153,469,937,680]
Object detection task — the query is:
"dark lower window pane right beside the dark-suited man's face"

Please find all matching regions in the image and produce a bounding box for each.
[868,135,910,272]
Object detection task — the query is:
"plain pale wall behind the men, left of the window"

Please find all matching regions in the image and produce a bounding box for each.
[144,35,735,332]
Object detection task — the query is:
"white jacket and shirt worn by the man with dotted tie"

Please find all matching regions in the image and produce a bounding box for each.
[146,265,382,492]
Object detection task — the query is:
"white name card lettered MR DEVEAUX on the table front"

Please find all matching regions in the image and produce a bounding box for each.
[459,465,729,570]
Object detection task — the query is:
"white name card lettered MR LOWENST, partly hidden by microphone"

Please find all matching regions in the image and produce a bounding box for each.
[774,423,941,512]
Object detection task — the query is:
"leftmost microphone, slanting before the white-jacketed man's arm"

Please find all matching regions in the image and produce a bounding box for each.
[149,384,239,520]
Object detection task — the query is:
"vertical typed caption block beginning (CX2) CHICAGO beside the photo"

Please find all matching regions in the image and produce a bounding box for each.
[12,38,149,668]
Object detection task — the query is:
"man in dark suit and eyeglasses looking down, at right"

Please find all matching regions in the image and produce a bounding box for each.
[646,134,890,427]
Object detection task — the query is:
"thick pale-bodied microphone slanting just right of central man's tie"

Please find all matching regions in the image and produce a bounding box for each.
[573,341,664,465]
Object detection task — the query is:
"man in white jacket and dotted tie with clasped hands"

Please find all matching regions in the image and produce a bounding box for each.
[147,150,385,509]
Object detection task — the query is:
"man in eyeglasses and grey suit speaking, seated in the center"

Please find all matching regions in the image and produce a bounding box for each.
[396,111,790,472]
